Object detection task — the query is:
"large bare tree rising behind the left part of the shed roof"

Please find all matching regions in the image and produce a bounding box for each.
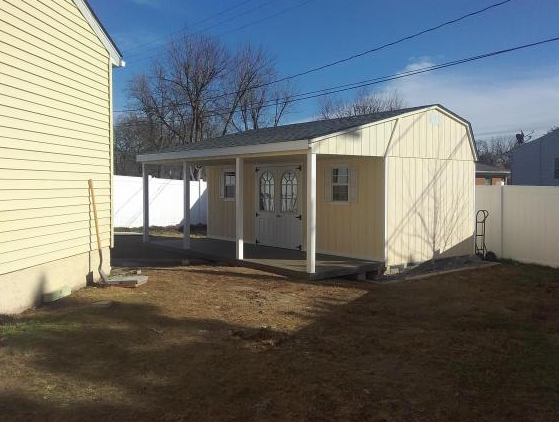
[115,35,300,177]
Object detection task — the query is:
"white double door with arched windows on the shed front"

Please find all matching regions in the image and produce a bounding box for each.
[255,165,303,250]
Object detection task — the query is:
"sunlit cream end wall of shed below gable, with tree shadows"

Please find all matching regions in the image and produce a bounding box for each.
[386,157,475,266]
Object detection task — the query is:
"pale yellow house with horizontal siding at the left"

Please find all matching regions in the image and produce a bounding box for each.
[0,0,124,313]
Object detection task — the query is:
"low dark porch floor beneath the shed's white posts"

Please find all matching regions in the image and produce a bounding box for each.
[148,237,384,280]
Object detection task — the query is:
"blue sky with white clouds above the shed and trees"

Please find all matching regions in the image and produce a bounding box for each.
[89,0,559,139]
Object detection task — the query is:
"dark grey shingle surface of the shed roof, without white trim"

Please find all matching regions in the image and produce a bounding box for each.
[160,105,432,152]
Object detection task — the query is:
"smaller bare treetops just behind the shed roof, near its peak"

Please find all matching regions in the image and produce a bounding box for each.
[318,89,405,119]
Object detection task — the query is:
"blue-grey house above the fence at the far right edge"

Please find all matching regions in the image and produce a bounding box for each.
[511,129,559,186]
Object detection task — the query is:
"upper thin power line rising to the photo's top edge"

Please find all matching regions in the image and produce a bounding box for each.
[123,0,513,95]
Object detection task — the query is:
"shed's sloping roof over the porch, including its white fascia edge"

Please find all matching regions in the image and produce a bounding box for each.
[137,105,436,163]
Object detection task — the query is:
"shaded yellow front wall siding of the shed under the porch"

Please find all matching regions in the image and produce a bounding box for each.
[206,157,384,259]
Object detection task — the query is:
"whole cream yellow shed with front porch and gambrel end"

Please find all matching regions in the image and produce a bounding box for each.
[138,105,476,279]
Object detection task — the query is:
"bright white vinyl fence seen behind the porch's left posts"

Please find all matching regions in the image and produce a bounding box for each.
[114,176,208,227]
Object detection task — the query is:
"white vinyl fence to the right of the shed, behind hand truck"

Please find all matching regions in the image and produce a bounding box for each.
[476,186,559,267]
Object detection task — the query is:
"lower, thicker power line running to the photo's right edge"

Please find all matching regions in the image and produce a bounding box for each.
[112,36,559,125]
